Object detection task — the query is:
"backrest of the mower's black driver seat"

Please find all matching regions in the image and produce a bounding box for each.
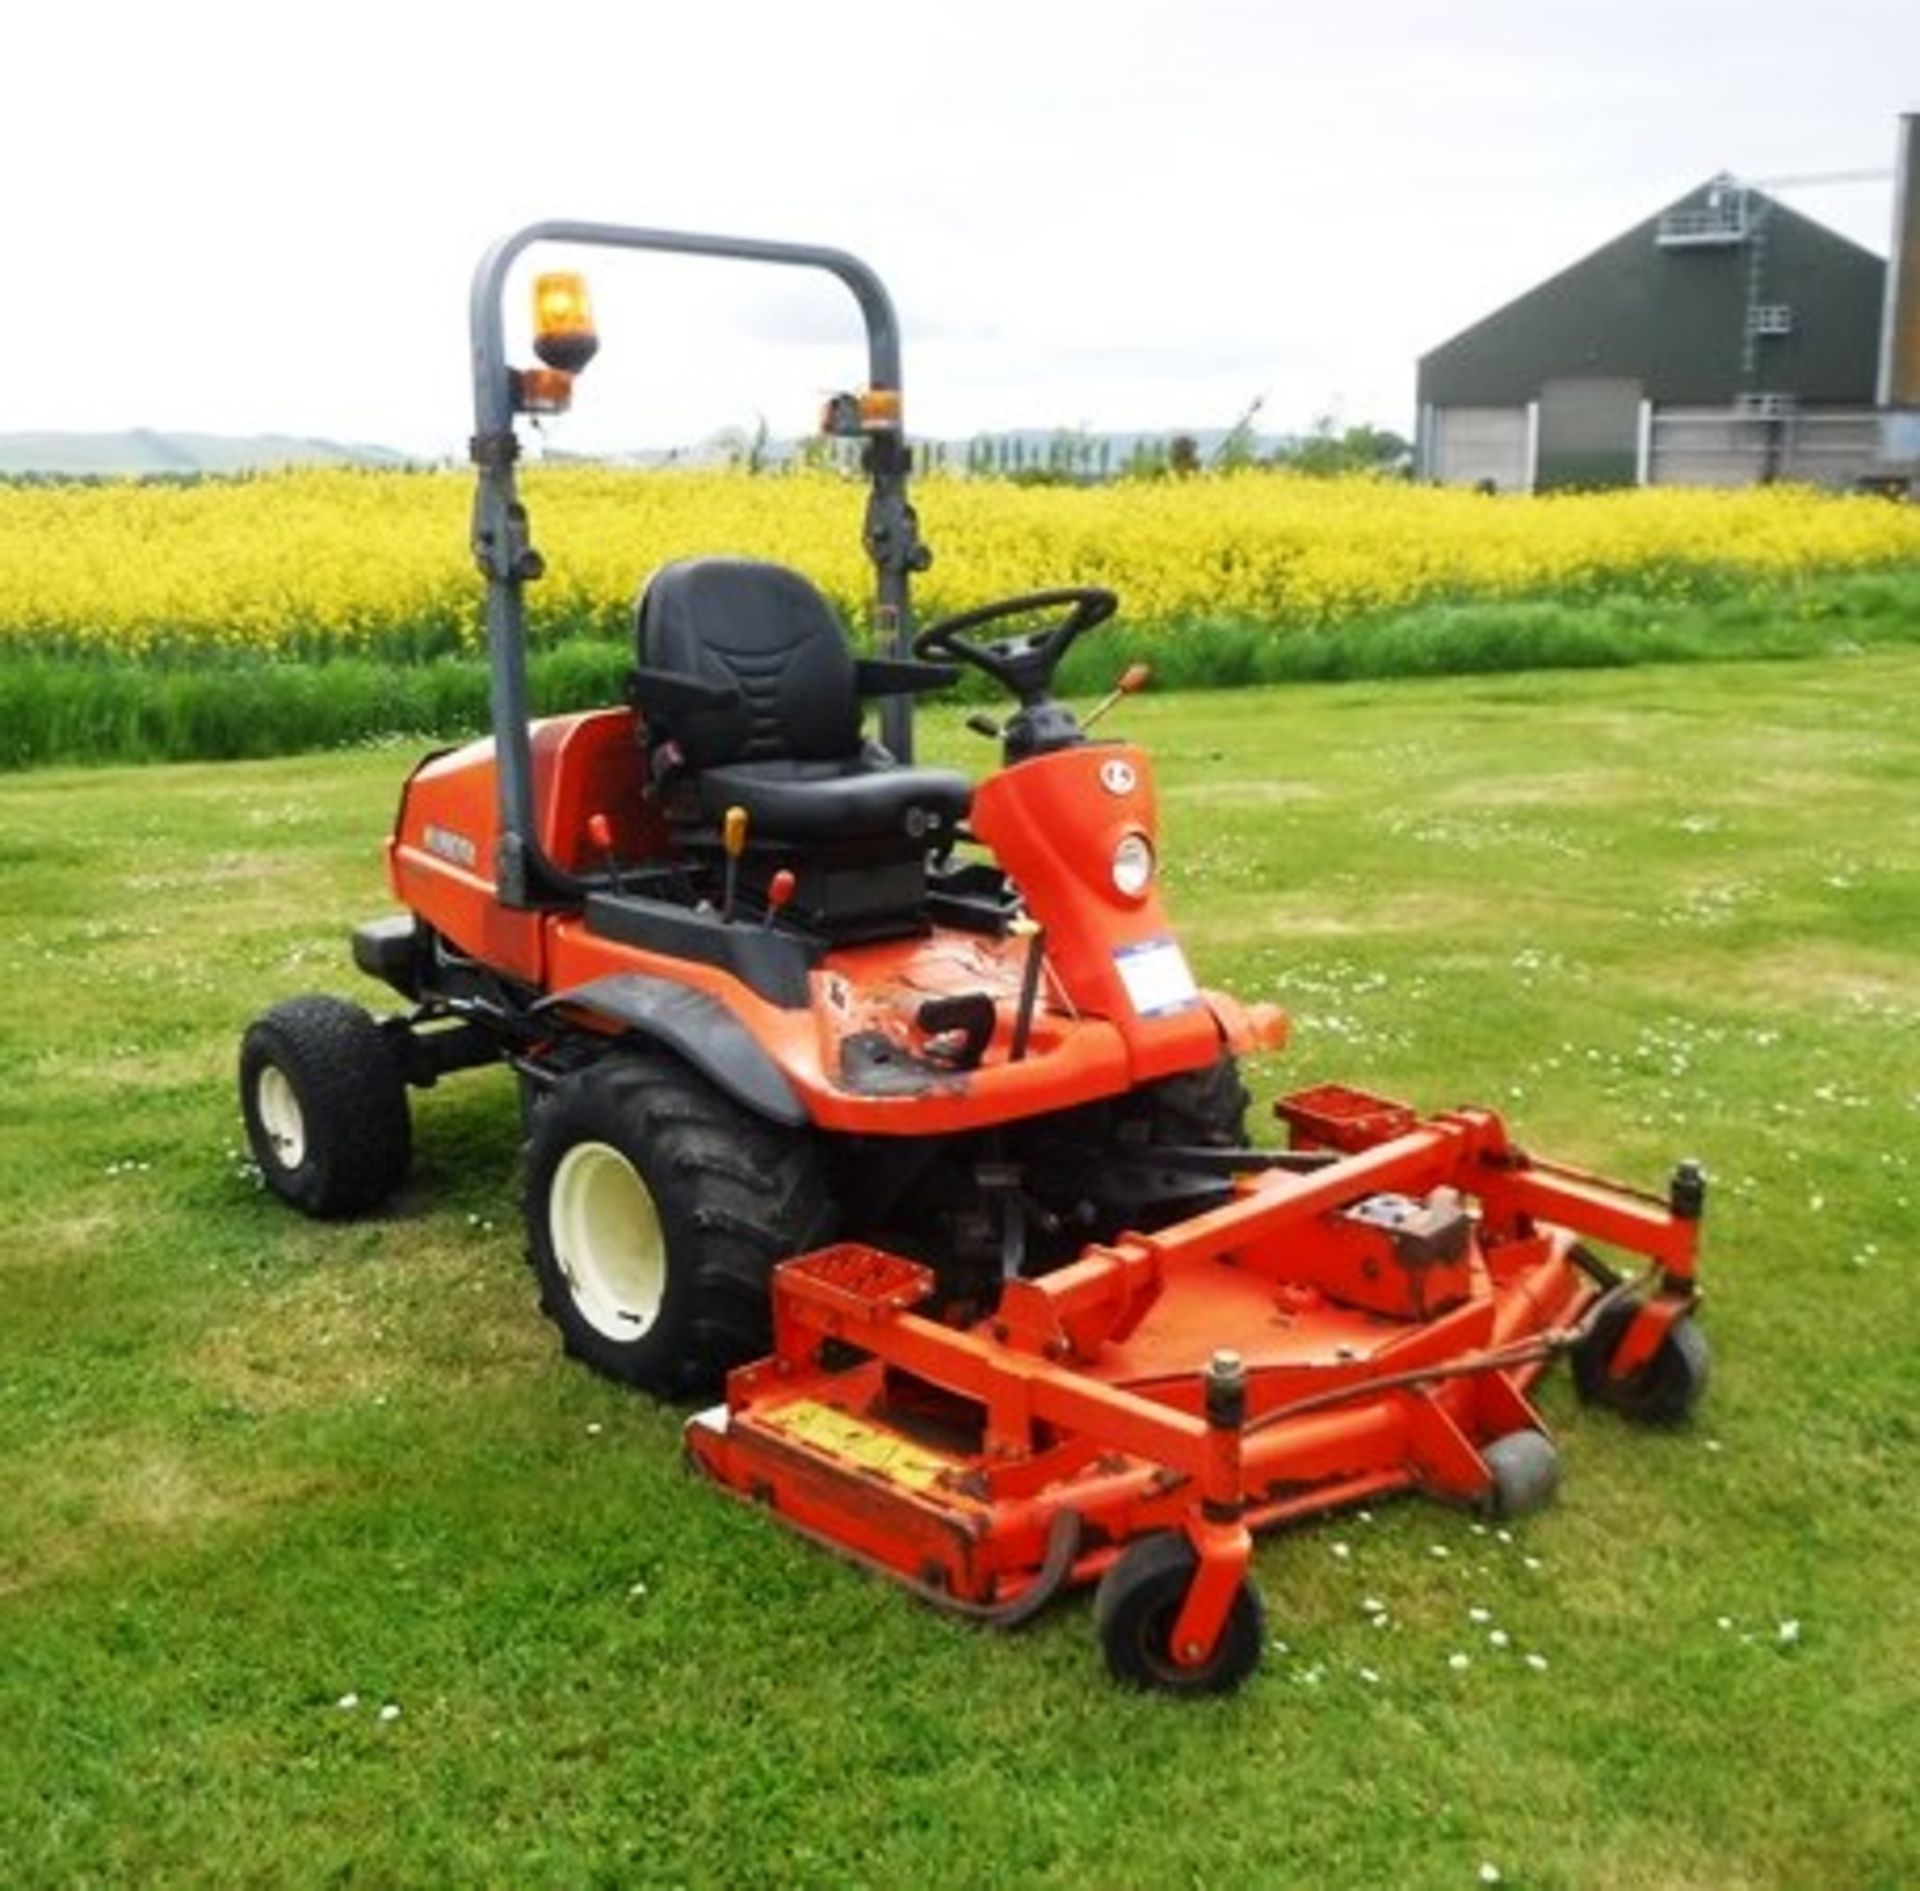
[637,559,860,768]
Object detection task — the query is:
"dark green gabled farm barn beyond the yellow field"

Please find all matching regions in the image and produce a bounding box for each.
[1415,119,1920,491]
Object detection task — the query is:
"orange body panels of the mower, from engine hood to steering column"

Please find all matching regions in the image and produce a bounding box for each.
[388,710,1284,1137]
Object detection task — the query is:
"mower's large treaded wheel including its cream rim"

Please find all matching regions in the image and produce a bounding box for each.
[526,1052,831,1398]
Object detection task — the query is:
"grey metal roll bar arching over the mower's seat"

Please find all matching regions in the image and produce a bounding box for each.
[470,219,929,906]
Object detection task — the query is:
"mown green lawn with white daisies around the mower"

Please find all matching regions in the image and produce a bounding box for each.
[0,651,1920,1891]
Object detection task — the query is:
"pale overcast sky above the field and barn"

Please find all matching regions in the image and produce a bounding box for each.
[0,0,1920,453]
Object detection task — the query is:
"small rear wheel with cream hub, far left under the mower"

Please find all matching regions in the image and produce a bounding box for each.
[240,996,413,1221]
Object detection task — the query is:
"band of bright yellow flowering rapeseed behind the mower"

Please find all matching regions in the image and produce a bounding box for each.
[0,467,1920,655]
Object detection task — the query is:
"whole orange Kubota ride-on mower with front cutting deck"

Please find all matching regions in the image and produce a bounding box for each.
[240,223,1707,1693]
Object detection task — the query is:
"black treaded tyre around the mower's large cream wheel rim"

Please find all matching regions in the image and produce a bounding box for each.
[526,1052,833,1398]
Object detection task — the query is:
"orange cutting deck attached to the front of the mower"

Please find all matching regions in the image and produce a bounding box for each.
[685,1087,1697,1691]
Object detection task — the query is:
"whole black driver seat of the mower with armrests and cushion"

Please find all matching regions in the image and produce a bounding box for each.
[634,559,973,844]
